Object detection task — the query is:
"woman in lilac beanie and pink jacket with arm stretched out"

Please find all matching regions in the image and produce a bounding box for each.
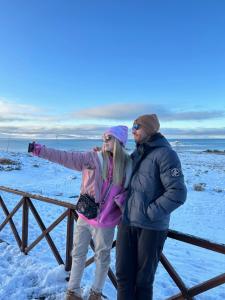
[30,126,131,300]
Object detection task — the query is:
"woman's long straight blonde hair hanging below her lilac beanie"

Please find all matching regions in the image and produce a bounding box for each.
[102,138,130,185]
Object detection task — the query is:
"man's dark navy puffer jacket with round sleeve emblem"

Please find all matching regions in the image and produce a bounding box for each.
[122,133,187,230]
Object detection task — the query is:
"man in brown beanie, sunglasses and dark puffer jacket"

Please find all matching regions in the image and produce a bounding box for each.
[116,114,187,300]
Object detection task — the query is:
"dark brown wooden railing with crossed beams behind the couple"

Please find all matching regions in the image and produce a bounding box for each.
[0,186,225,300]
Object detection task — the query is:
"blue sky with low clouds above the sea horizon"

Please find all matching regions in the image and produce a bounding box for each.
[0,0,225,138]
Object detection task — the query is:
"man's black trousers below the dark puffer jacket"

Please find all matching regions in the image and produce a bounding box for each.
[116,224,167,300]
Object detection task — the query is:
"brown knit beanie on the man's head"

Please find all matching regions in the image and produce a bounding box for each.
[134,114,160,136]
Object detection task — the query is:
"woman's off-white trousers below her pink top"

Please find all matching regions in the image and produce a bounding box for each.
[68,218,115,294]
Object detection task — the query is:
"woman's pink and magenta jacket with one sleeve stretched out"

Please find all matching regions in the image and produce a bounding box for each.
[38,146,131,227]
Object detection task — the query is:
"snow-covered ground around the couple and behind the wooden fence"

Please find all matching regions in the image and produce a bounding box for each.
[0,151,225,300]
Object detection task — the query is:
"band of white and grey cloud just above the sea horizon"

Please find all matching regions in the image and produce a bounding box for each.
[0,98,225,138]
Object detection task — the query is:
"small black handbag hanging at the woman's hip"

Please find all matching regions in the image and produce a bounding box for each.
[76,194,99,219]
